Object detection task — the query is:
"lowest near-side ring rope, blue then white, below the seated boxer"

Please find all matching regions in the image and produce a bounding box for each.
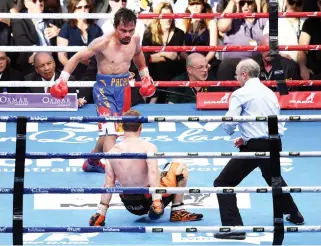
[0,226,321,233]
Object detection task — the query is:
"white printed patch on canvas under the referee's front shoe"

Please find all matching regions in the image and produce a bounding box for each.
[172,232,273,245]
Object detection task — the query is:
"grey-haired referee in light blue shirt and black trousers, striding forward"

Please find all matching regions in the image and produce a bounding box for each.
[214,59,304,240]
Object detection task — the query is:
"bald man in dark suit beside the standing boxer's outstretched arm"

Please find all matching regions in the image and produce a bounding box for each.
[24,52,87,107]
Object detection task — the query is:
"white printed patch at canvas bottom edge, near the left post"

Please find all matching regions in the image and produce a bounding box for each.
[23,233,99,245]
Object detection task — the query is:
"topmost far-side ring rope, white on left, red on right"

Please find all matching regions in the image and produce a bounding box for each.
[0,12,321,19]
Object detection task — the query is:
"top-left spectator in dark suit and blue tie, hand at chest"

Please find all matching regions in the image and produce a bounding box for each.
[12,0,60,75]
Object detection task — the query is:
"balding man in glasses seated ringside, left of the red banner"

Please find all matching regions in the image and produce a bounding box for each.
[167,53,214,104]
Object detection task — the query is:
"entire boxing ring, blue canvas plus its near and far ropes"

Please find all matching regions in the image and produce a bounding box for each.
[0,4,321,245]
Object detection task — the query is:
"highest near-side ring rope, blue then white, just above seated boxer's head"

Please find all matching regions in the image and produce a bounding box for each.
[0,115,321,123]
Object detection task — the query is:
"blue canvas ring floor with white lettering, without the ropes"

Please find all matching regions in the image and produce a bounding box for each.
[0,104,321,245]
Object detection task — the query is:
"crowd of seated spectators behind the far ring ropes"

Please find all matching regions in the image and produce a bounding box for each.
[0,0,321,105]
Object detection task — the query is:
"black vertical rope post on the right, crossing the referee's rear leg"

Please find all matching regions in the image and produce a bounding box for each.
[268,115,284,245]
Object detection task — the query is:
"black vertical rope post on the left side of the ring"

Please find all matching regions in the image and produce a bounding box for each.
[12,116,27,245]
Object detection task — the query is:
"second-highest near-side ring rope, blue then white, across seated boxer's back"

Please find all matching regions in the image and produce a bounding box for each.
[0,151,321,159]
